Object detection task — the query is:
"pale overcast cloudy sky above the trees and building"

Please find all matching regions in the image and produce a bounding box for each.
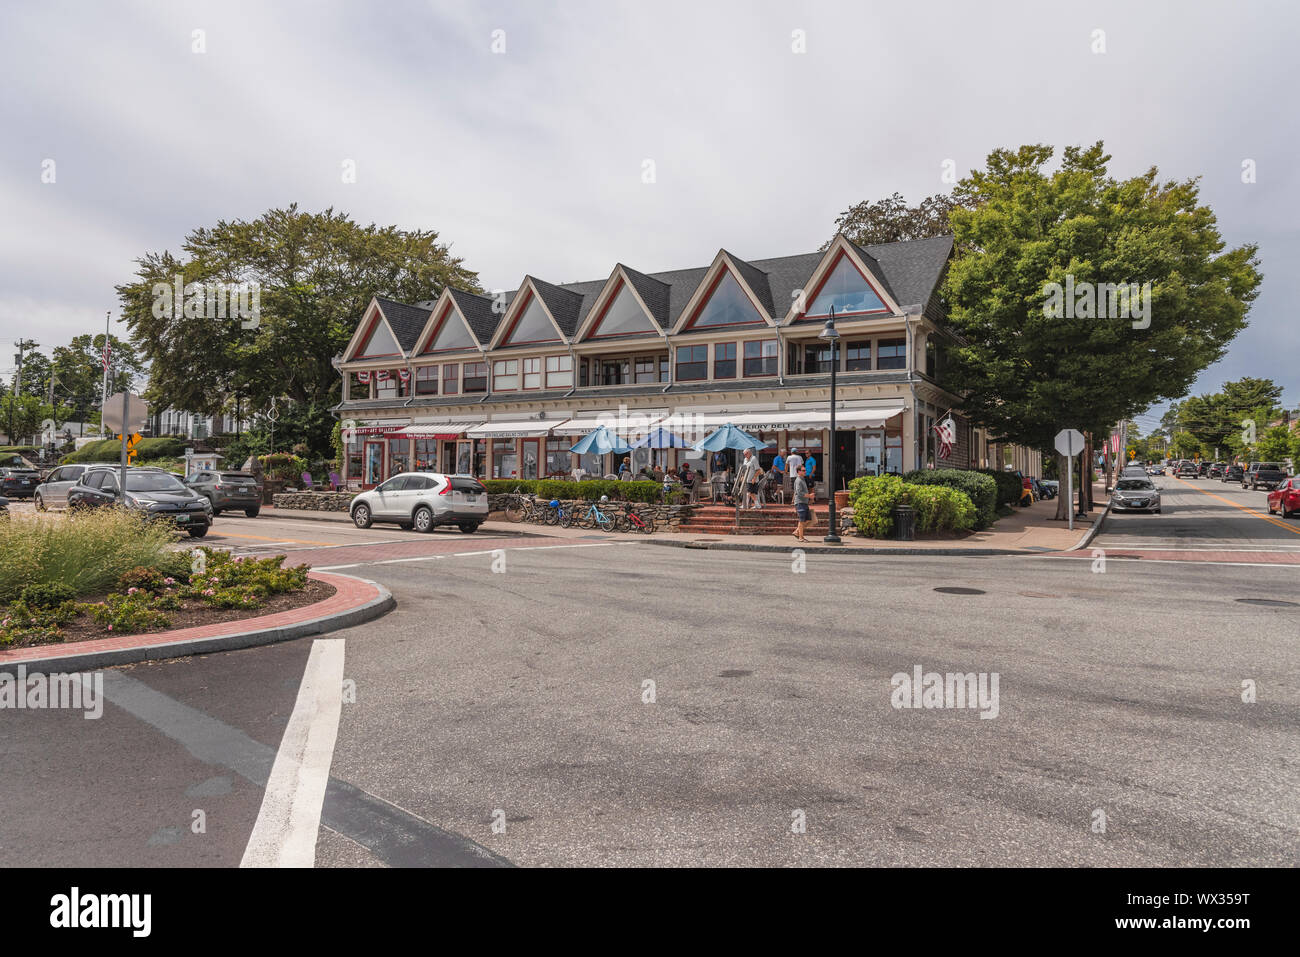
[0,0,1300,426]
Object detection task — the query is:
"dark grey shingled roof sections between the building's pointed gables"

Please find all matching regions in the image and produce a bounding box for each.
[356,235,953,352]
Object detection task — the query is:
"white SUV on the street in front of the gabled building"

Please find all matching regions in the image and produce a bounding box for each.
[348,472,488,534]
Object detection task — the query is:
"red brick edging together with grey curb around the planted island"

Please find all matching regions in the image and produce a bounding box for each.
[0,572,397,674]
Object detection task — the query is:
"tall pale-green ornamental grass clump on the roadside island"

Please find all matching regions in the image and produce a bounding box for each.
[0,508,189,603]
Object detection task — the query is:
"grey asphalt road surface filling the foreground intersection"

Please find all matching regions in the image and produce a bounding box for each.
[0,480,1300,866]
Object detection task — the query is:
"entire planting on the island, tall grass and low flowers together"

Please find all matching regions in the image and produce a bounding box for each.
[0,508,334,649]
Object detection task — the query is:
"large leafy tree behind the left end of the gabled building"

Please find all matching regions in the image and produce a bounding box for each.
[117,204,477,415]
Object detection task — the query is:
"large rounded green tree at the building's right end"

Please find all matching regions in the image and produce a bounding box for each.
[944,143,1261,518]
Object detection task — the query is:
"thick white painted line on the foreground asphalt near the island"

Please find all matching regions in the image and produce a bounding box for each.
[239,638,343,867]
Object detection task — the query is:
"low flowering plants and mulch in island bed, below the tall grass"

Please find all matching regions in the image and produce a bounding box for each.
[0,547,334,649]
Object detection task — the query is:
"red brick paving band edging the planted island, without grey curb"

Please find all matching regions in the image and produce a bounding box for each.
[0,572,381,664]
